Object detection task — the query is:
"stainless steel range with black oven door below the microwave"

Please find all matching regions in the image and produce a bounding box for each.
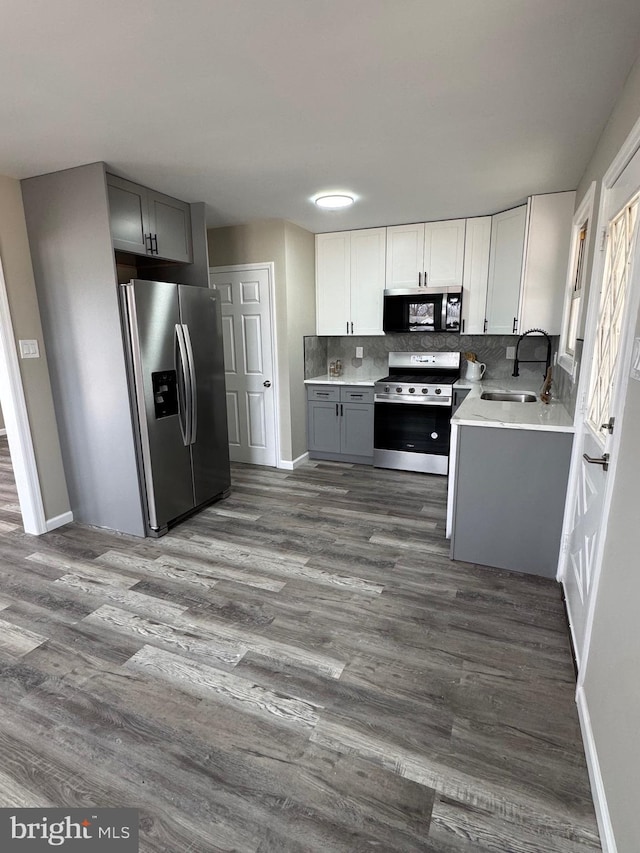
[373,352,460,474]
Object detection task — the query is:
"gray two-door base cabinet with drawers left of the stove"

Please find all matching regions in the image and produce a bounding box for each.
[307,384,373,465]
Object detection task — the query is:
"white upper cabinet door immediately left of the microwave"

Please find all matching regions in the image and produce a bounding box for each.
[349,228,387,335]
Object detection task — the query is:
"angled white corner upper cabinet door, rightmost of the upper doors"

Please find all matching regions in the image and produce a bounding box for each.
[487,204,527,335]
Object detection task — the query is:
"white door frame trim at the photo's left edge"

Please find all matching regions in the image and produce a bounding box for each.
[0,258,47,536]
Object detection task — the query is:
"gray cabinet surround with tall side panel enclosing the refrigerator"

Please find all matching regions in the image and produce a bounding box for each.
[21,163,209,536]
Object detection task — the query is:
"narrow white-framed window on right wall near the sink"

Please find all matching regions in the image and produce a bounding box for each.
[558,183,595,378]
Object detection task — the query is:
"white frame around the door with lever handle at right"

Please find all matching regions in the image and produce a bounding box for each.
[557,119,640,693]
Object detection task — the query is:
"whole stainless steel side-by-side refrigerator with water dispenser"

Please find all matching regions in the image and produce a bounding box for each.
[121,279,230,535]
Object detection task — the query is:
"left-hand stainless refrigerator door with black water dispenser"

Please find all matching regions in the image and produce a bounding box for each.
[125,280,195,530]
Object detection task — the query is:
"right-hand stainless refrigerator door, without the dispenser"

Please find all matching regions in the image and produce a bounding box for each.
[178,284,231,505]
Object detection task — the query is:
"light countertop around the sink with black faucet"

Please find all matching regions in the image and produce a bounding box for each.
[451,377,573,432]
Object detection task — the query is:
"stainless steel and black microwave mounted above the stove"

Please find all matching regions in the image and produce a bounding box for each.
[382,287,462,332]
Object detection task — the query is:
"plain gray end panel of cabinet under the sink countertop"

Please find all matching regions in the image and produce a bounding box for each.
[451,426,573,578]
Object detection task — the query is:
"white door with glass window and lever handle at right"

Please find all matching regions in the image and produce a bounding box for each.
[561,166,640,666]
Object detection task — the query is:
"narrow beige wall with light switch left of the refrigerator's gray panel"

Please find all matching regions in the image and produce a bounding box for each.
[0,175,69,519]
